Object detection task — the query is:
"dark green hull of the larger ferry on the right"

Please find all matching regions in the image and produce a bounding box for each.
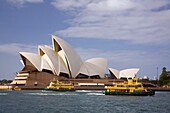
[104,91,155,96]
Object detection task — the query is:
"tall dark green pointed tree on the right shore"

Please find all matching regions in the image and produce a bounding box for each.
[158,67,167,86]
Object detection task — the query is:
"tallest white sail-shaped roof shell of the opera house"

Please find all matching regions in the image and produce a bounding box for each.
[52,35,82,78]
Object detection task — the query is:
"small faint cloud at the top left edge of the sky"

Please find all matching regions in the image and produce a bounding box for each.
[6,0,44,7]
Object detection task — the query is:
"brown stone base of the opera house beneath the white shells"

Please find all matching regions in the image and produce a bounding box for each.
[12,72,159,90]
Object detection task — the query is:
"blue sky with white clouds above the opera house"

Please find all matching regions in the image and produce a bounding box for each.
[0,0,170,79]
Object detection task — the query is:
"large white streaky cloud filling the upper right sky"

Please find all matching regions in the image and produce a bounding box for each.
[53,0,170,44]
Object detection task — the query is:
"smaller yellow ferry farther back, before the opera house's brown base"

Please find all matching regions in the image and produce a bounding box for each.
[45,80,75,91]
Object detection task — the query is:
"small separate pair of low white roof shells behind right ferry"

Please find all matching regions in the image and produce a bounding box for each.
[109,68,139,79]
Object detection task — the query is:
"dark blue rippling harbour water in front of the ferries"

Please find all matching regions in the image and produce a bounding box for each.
[0,91,170,113]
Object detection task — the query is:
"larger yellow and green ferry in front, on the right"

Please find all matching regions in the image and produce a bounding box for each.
[104,78,155,96]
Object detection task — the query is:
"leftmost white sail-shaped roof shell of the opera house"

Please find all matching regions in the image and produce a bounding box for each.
[19,52,41,71]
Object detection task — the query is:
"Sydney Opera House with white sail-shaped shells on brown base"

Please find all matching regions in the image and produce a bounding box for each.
[11,35,139,87]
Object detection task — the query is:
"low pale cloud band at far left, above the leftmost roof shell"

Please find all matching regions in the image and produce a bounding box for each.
[0,43,37,55]
